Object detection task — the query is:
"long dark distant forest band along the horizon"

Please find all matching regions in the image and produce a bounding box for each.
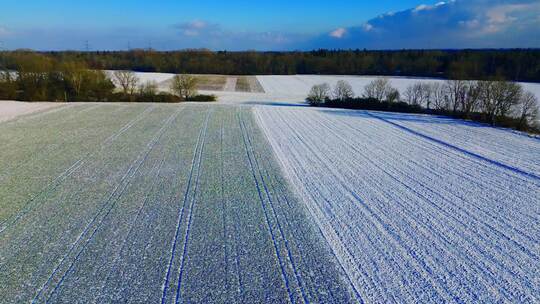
[0,49,540,82]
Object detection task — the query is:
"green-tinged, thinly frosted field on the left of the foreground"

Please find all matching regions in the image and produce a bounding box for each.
[0,104,355,303]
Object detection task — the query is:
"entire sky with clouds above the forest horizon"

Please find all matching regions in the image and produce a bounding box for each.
[0,0,540,50]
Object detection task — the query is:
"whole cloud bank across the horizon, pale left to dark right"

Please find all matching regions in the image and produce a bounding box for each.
[0,0,540,50]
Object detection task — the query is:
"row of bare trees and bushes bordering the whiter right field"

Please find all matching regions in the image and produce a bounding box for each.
[306,78,540,132]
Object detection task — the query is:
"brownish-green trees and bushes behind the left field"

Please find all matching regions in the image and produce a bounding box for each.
[0,51,216,102]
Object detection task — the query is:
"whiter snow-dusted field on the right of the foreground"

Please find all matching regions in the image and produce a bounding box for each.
[255,107,540,303]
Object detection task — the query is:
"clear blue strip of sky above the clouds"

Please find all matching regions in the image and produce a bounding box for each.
[0,0,435,32]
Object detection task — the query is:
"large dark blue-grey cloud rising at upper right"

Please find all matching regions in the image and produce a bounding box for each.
[312,0,540,49]
